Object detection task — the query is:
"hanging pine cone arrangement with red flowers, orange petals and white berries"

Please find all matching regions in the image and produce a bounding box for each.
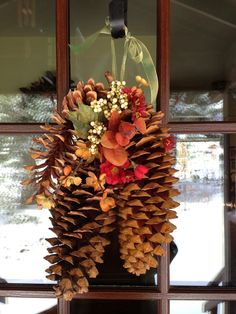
[23,72,179,300]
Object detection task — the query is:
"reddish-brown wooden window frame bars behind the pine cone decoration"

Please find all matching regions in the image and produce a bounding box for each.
[0,0,236,314]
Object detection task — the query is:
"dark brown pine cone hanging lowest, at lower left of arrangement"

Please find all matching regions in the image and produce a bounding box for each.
[45,167,116,300]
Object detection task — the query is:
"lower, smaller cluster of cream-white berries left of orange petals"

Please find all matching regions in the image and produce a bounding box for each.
[88,121,107,155]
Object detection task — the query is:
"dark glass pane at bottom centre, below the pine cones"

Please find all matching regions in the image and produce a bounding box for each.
[71,300,157,314]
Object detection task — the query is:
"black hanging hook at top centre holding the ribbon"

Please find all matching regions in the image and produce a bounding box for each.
[109,0,128,38]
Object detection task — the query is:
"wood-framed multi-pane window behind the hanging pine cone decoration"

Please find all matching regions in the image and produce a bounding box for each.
[0,0,236,314]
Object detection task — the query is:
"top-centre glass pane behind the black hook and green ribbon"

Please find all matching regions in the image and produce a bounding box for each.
[70,0,156,84]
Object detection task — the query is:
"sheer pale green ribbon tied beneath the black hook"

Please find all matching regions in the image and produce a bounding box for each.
[70,20,158,104]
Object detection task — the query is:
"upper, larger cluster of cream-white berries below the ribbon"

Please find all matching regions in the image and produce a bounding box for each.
[90,81,128,119]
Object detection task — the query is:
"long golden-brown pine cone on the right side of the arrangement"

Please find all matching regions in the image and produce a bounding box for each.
[117,110,179,276]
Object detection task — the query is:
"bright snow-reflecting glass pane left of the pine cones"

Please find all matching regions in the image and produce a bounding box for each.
[0,136,52,283]
